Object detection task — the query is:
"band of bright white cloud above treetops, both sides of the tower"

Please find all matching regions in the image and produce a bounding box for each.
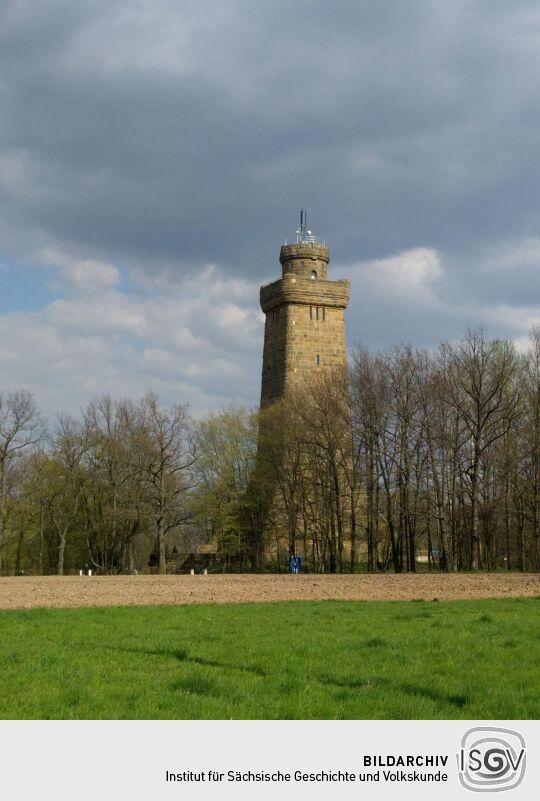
[5,240,540,416]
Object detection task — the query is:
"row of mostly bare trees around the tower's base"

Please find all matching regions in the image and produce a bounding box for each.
[0,329,540,575]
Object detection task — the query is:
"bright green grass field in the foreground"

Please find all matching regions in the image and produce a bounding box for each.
[0,599,540,719]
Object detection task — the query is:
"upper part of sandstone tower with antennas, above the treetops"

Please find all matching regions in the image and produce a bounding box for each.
[261,211,350,406]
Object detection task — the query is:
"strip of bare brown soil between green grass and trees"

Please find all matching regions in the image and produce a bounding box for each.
[0,573,540,609]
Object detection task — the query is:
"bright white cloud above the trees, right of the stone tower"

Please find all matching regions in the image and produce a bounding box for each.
[340,239,540,348]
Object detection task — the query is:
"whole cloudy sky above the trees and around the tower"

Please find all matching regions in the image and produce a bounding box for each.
[0,0,540,415]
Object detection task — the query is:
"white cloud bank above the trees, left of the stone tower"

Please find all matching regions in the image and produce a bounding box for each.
[0,254,263,415]
